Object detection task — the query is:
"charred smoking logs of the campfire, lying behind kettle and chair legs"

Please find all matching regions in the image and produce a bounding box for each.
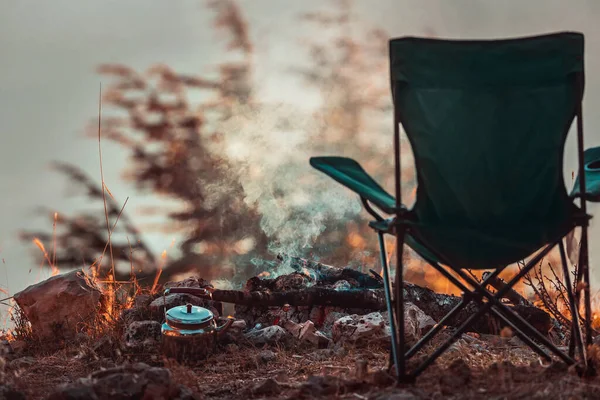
[163,256,552,334]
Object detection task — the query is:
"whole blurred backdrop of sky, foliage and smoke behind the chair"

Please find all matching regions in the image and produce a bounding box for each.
[0,0,600,318]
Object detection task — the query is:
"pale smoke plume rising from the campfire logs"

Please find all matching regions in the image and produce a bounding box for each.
[220,104,361,274]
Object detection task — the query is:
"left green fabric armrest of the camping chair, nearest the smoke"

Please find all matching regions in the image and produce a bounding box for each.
[310,157,396,214]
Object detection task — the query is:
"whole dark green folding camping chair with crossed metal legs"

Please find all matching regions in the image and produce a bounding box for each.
[310,32,600,382]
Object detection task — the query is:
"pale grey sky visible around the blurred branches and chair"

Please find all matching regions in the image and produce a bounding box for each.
[0,0,600,310]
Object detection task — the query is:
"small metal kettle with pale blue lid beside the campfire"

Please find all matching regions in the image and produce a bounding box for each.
[161,288,234,361]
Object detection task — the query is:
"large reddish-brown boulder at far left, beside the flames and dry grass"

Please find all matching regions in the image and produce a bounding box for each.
[14,270,102,341]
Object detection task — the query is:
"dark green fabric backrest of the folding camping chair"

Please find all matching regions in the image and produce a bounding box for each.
[390,32,584,229]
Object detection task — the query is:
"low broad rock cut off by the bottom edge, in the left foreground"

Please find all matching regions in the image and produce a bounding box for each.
[47,363,197,400]
